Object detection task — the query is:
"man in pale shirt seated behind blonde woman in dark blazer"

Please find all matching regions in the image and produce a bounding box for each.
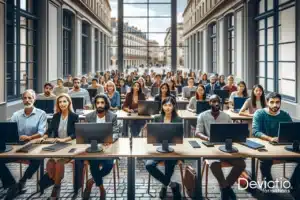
[69,77,91,108]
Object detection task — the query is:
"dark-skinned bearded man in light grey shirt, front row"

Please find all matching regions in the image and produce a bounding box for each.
[195,94,246,200]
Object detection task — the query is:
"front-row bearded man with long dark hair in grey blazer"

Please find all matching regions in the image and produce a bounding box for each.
[83,94,119,200]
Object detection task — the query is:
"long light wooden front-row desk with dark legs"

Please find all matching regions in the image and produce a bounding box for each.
[0,138,300,200]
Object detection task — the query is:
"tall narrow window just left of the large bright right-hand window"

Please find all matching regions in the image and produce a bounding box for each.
[226,14,236,74]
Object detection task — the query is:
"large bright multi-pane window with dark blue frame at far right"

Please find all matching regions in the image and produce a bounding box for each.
[256,0,296,101]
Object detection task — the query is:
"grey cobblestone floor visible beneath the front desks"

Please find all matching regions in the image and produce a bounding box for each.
[0,159,294,200]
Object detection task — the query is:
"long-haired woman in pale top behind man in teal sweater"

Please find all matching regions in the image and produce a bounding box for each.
[239,85,266,117]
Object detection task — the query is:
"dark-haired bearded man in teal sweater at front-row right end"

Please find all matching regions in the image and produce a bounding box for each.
[252,92,300,195]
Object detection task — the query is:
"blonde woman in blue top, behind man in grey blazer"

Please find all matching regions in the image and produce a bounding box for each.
[105,81,121,110]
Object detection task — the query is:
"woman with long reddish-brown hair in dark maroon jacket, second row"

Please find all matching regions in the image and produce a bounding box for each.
[123,82,146,137]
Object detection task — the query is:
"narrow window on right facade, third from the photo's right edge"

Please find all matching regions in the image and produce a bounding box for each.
[209,23,217,72]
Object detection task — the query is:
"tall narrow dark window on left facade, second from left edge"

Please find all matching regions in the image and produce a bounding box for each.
[63,10,73,77]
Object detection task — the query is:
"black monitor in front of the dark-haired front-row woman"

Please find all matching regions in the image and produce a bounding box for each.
[147,123,183,153]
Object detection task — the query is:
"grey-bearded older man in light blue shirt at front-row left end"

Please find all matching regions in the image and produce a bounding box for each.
[0,89,47,199]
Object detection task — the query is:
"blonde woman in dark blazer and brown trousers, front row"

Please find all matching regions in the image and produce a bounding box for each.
[40,93,79,198]
